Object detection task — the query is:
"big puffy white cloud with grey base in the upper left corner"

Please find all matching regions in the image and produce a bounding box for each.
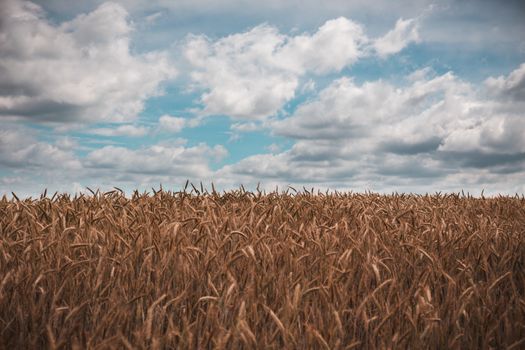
[0,0,175,122]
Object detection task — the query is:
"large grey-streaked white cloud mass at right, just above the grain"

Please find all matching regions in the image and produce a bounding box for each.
[220,63,525,192]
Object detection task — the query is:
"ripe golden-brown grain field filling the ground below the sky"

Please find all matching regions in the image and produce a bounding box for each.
[0,189,525,349]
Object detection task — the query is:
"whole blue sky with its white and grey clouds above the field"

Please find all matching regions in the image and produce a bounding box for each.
[0,0,525,197]
